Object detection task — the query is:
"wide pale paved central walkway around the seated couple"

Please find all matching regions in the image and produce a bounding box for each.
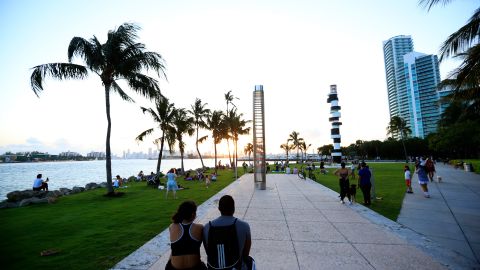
[114,174,480,270]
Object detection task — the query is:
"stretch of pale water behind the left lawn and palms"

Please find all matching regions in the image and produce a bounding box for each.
[0,159,228,201]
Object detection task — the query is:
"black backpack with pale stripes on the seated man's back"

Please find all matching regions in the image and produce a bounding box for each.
[207,219,242,269]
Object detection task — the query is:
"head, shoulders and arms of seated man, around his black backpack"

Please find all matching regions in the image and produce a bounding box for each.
[203,195,252,269]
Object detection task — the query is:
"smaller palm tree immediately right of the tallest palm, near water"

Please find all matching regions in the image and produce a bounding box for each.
[135,97,176,174]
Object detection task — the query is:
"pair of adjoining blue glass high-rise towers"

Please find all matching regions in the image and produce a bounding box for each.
[383,36,449,138]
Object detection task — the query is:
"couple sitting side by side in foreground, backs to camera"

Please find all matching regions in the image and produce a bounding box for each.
[165,195,254,270]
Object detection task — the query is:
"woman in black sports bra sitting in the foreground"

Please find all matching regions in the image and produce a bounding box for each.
[165,201,207,270]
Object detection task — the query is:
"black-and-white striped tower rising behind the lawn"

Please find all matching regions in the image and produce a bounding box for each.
[327,84,342,163]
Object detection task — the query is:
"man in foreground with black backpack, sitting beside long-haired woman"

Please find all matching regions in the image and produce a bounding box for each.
[203,195,253,269]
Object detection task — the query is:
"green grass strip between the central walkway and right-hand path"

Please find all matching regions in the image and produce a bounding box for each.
[271,163,413,221]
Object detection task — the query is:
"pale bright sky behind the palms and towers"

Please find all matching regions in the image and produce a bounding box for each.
[0,0,478,156]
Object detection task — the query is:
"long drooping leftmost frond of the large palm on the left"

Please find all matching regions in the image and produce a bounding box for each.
[30,63,88,97]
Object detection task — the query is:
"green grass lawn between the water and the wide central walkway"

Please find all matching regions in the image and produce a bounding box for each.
[0,170,243,269]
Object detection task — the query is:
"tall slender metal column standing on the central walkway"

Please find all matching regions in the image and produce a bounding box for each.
[253,85,267,190]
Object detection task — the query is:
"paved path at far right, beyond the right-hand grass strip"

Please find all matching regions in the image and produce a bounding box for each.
[397,164,480,267]
